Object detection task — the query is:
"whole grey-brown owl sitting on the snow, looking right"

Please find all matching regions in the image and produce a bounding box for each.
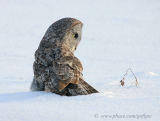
[31,18,98,96]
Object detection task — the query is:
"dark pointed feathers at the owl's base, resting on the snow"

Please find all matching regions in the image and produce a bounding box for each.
[59,79,98,96]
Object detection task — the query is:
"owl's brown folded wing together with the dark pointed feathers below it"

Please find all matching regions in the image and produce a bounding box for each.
[53,56,98,96]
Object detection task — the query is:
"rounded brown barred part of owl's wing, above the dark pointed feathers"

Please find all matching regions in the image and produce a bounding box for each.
[54,56,83,91]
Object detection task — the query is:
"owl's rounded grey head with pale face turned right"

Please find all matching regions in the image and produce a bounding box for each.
[40,18,83,52]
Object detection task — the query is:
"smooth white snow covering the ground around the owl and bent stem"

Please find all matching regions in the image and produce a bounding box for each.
[0,0,160,121]
